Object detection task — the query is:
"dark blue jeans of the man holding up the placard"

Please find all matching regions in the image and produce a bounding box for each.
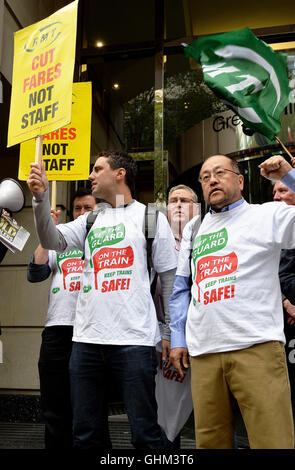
[70,342,167,450]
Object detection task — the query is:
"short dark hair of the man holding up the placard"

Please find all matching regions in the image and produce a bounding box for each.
[98,150,137,195]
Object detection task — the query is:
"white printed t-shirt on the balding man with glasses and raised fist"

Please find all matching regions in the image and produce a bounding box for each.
[176,202,295,356]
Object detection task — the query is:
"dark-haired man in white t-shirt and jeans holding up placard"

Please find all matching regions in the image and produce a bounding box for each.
[28,152,177,450]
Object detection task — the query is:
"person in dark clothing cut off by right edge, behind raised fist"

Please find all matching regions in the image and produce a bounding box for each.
[273,181,295,409]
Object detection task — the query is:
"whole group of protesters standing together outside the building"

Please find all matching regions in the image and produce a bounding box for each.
[22,151,295,451]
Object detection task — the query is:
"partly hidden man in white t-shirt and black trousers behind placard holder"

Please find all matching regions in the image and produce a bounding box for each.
[27,188,100,449]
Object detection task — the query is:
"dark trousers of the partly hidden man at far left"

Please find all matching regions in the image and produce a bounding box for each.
[38,326,73,449]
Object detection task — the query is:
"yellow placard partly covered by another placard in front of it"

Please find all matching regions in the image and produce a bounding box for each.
[18,82,92,181]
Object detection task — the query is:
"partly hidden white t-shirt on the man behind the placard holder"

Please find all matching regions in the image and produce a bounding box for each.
[45,249,85,326]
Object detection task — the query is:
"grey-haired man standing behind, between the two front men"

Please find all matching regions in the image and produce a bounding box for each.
[154,184,199,449]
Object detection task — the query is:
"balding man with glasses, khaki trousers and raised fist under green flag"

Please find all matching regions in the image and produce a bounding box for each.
[170,155,295,449]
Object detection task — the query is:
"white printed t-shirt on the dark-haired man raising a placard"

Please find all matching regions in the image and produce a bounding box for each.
[57,201,177,346]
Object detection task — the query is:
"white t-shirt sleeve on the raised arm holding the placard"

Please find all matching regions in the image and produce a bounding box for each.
[56,213,88,251]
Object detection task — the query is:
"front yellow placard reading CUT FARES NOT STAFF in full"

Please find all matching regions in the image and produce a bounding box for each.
[7,0,78,147]
